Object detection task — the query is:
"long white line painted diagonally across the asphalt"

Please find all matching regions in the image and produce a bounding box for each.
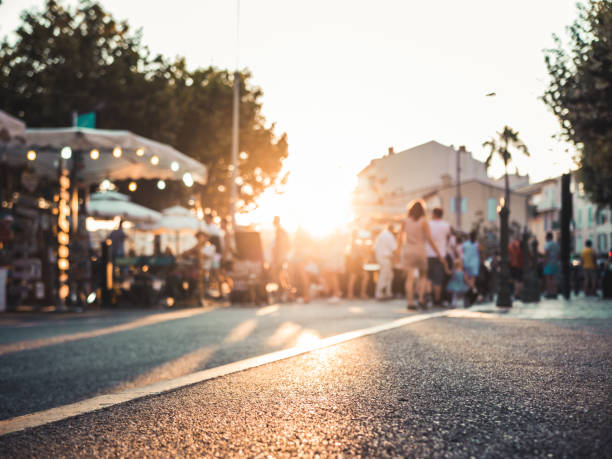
[0,311,449,436]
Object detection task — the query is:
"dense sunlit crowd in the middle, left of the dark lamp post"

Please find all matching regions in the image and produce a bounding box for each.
[270,200,485,309]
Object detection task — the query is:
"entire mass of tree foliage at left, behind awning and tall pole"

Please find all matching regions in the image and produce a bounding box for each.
[0,0,288,213]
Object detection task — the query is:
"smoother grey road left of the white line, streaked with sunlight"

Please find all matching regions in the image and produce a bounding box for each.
[0,302,406,419]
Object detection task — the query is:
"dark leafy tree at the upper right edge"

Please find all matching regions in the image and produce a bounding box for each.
[543,0,612,205]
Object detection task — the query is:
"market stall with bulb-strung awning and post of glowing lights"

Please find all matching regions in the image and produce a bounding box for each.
[3,127,207,306]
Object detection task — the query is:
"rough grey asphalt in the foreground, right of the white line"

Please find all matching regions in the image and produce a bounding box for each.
[0,317,612,457]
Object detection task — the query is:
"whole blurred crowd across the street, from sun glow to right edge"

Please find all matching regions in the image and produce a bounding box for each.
[270,200,608,309]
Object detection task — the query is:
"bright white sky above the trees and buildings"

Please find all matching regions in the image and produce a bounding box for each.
[0,0,577,234]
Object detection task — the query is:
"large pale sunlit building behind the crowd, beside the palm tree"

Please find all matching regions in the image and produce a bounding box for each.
[353,141,529,231]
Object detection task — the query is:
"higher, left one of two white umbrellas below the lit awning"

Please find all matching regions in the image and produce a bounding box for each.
[87,191,162,223]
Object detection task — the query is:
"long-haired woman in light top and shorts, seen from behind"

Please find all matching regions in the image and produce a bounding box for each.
[398,199,448,309]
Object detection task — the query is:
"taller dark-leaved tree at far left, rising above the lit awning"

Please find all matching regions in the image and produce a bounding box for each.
[0,0,178,143]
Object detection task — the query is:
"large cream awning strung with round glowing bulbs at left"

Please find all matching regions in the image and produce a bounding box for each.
[9,127,207,186]
